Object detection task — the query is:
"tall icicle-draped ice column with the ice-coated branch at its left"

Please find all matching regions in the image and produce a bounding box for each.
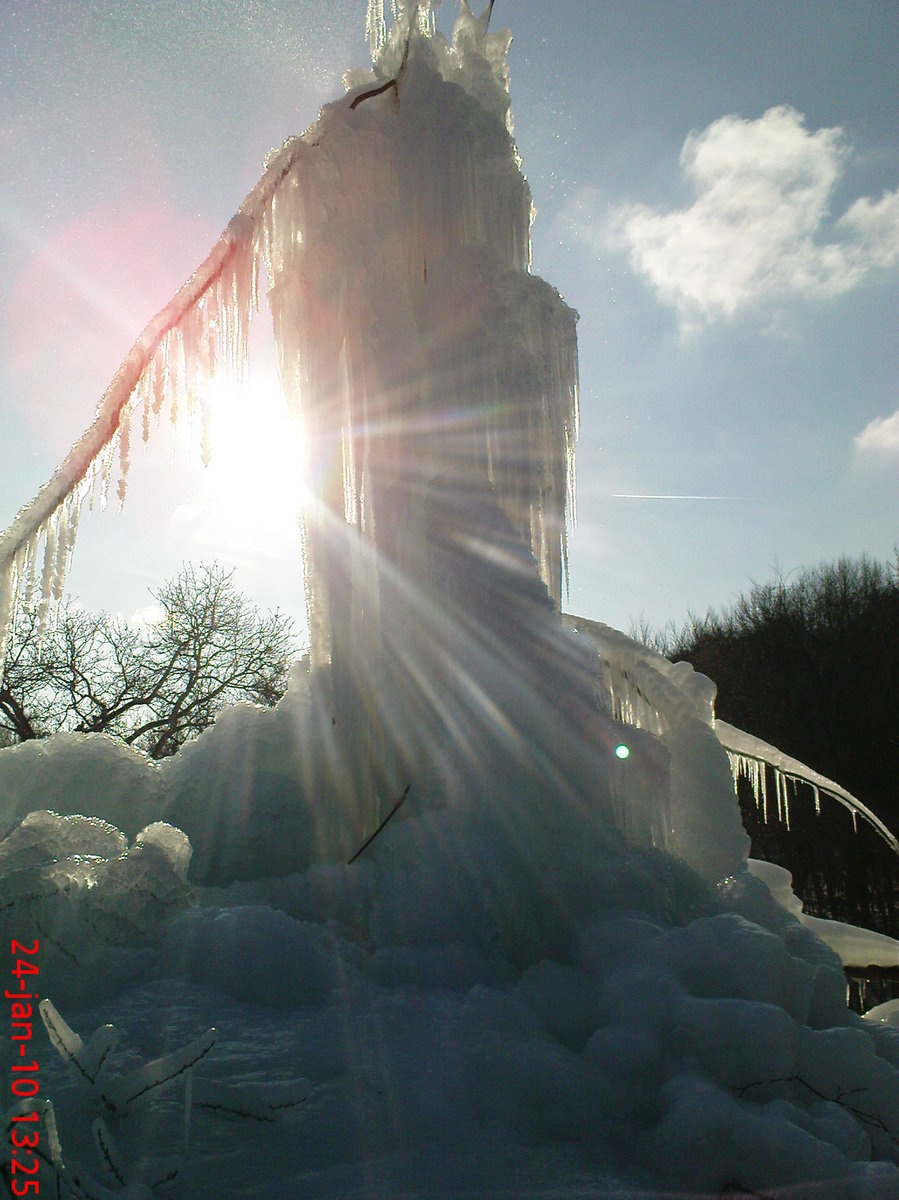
[0,4,710,877]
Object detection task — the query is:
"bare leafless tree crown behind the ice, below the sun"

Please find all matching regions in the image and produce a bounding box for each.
[0,564,296,758]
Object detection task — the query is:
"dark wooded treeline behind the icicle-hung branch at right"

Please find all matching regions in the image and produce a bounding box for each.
[640,556,899,960]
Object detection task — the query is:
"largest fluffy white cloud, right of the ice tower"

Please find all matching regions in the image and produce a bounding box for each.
[607,106,899,324]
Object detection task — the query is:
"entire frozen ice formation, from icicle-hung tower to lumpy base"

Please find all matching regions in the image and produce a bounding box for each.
[0,0,899,1200]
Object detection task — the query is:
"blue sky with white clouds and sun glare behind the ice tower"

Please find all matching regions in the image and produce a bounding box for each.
[0,0,899,630]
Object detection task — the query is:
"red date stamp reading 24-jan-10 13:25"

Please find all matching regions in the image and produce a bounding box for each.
[4,938,41,1196]
